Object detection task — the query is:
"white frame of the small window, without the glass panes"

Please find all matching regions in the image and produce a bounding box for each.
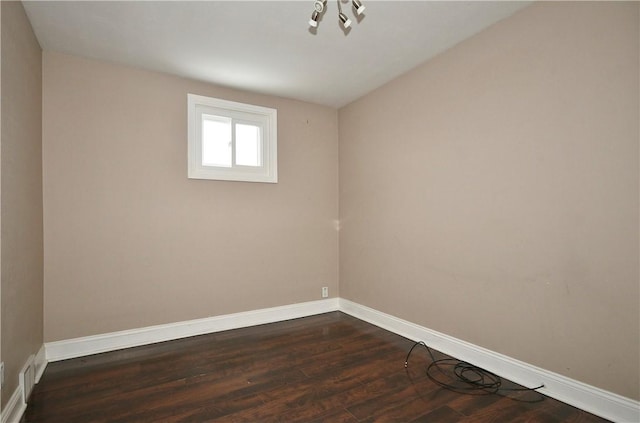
[187,94,278,183]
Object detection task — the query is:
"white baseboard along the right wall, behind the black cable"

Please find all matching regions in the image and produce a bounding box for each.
[338,298,640,423]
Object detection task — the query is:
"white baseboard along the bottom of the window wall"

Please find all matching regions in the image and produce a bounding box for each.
[45,298,338,362]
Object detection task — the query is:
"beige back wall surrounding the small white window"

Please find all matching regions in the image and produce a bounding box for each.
[43,52,338,341]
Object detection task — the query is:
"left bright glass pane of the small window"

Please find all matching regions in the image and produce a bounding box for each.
[202,115,231,167]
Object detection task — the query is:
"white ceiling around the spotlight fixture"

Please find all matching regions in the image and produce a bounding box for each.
[24,0,530,107]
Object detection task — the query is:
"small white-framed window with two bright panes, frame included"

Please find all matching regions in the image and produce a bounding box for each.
[187,94,278,183]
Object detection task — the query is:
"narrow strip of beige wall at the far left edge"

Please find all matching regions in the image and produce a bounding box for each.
[0,1,43,406]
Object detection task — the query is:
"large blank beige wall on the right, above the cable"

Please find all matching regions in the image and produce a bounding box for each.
[339,2,640,399]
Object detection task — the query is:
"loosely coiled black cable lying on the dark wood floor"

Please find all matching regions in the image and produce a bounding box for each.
[404,341,544,402]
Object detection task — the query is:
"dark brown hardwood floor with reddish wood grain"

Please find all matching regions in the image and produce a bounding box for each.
[22,312,606,423]
